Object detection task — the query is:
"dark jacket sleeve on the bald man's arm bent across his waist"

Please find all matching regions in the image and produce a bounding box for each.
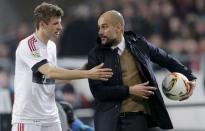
[87,48,129,102]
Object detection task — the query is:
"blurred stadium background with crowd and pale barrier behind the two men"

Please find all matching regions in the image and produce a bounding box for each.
[0,0,205,131]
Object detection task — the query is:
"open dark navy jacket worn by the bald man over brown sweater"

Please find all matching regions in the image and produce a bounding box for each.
[88,31,196,131]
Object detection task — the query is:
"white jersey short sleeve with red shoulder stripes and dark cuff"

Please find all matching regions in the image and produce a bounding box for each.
[16,41,48,72]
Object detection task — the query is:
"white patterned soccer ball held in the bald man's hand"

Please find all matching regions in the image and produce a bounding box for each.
[162,72,188,101]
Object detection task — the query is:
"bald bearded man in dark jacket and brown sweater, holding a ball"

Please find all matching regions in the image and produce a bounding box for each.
[88,10,196,131]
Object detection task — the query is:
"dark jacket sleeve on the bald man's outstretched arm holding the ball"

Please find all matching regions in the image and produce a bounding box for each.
[144,39,196,81]
